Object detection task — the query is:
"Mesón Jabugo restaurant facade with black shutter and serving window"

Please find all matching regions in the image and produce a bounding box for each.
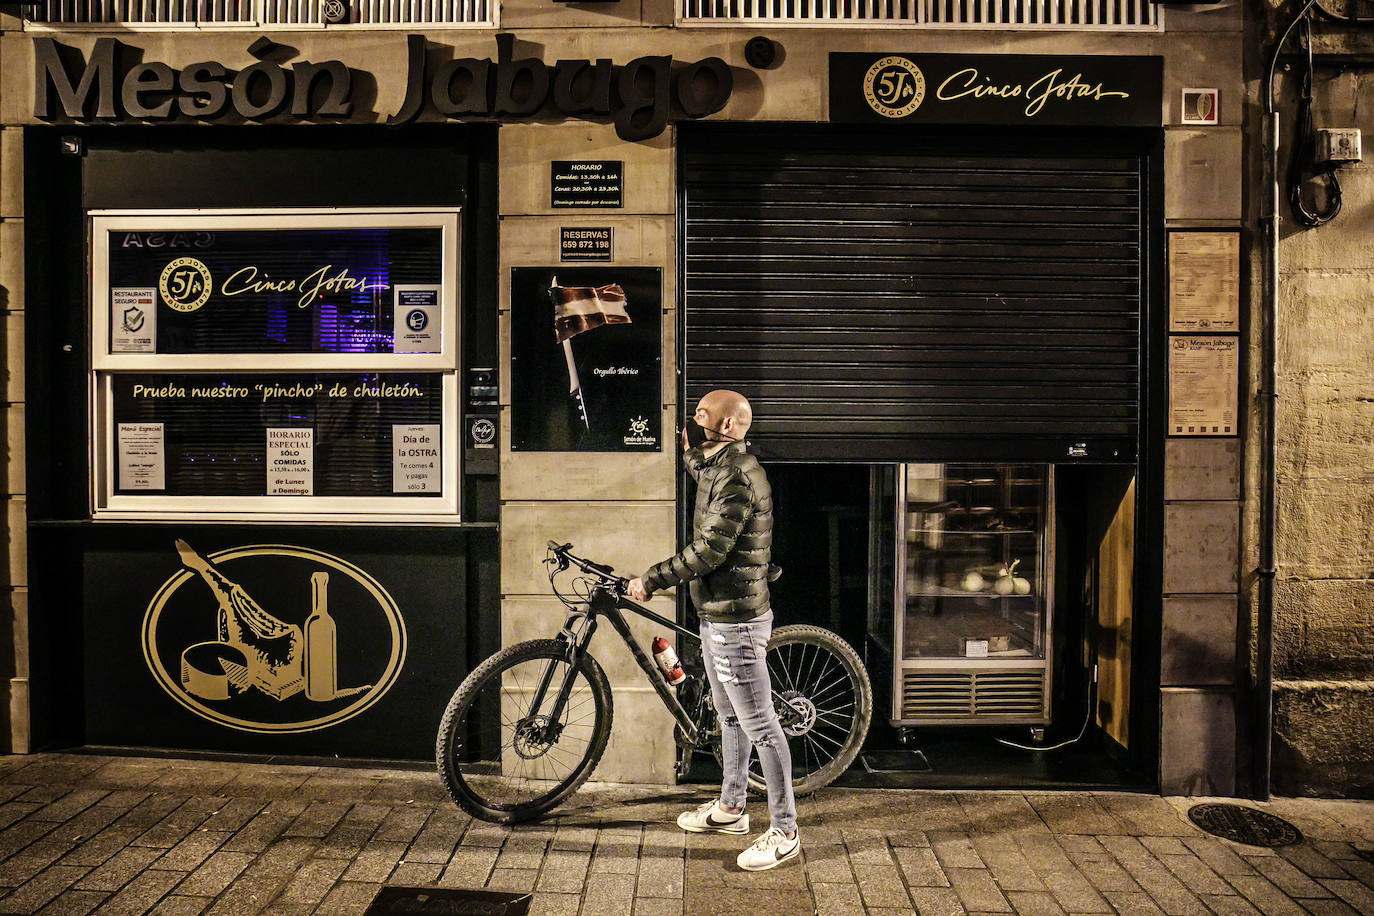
[0,0,1329,795]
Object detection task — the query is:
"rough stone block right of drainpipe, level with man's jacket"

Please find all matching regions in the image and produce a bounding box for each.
[1274,475,1374,580]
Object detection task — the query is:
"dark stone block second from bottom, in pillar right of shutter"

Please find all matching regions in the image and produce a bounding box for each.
[1160,595,1239,687]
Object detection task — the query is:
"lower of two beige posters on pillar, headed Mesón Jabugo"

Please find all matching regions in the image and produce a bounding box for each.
[1169,335,1241,435]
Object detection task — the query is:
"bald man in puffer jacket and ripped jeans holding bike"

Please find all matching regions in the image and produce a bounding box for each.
[628,390,801,871]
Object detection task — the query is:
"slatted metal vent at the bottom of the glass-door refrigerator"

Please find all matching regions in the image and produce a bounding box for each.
[901,670,1044,722]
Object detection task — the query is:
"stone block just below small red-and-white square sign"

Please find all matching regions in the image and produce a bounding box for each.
[1164,128,1245,220]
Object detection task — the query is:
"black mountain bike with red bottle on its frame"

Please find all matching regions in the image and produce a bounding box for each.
[434,541,872,824]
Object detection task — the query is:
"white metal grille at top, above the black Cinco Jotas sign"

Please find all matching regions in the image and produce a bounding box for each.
[680,0,1161,25]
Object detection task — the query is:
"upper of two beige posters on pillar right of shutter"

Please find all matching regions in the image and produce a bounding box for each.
[1169,232,1241,334]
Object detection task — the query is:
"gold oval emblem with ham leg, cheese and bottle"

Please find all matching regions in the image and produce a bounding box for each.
[143,540,405,733]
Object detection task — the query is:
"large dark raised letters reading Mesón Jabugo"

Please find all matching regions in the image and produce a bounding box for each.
[33,34,734,141]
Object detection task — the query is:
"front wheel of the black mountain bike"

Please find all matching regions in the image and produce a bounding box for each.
[434,640,611,824]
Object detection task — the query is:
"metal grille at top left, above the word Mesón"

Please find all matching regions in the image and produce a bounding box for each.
[30,0,493,26]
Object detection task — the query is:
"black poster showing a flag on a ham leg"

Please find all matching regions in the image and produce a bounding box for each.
[511,266,662,452]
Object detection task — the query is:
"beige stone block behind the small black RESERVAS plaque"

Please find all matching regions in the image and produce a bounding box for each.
[502,210,676,269]
